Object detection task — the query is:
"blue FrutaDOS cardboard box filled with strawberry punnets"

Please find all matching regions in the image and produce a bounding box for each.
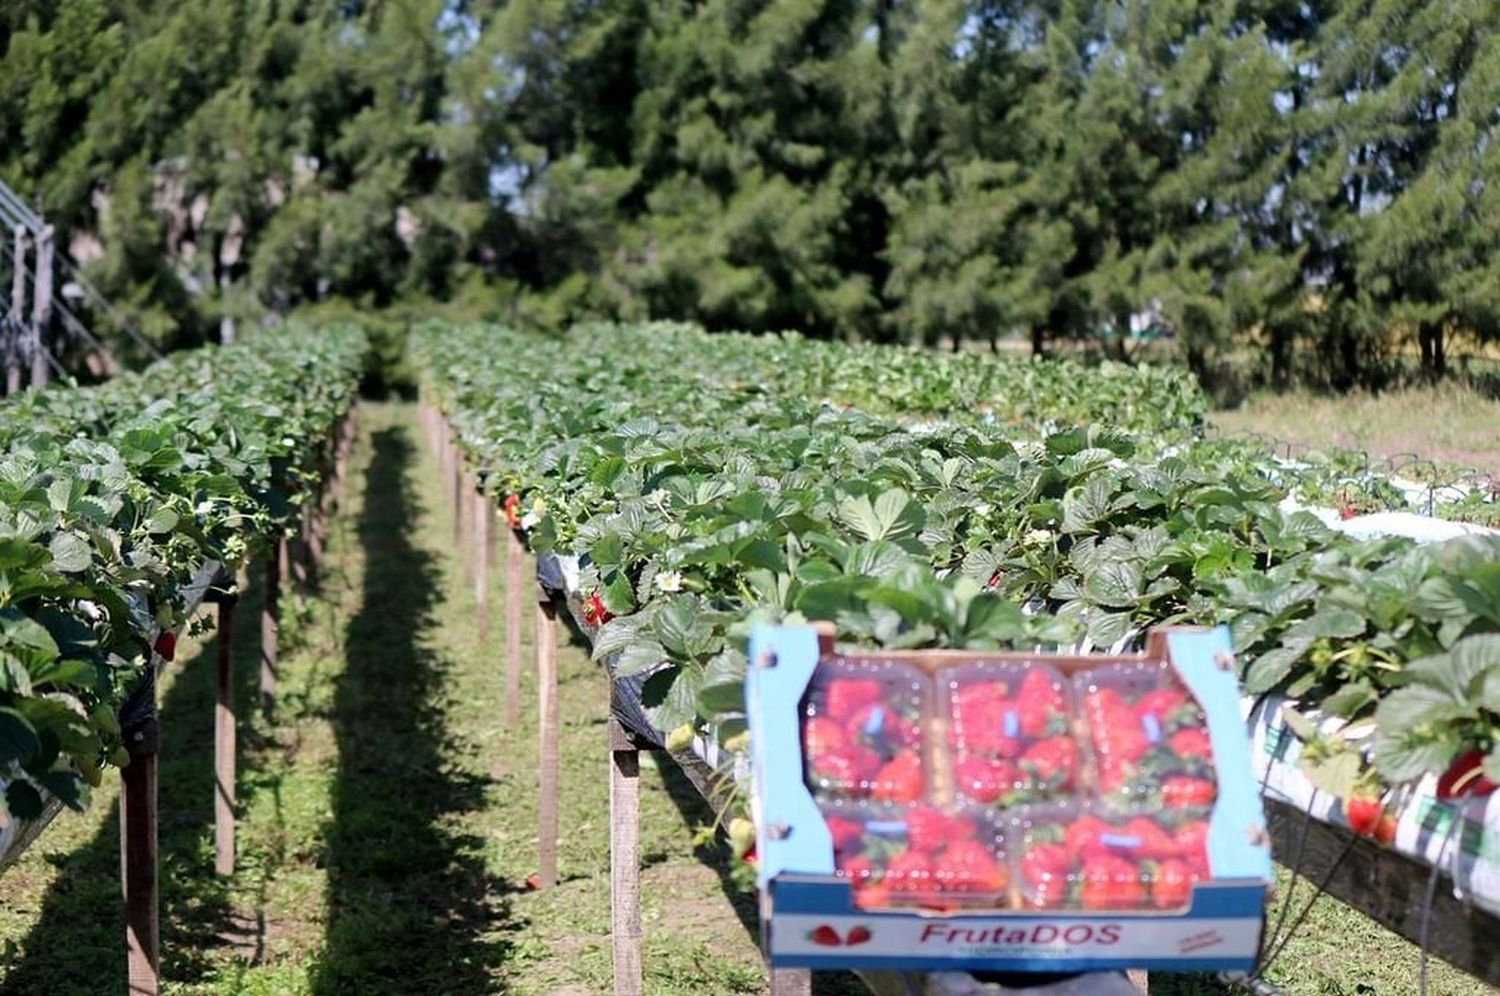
[746,627,1271,972]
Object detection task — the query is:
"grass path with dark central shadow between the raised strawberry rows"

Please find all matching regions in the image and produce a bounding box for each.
[0,405,786,996]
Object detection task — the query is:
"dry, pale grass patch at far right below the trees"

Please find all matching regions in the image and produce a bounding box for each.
[1211,383,1500,477]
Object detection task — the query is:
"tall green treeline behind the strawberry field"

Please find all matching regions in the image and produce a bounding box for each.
[0,0,1500,386]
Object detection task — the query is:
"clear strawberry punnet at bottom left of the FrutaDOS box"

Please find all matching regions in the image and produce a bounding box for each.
[824,804,1010,909]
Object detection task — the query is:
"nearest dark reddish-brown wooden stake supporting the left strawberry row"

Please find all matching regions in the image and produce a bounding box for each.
[120,753,161,996]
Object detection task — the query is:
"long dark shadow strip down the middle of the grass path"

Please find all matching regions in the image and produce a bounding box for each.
[312,428,507,996]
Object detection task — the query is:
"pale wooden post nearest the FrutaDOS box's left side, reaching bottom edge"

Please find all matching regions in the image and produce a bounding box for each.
[609,716,645,996]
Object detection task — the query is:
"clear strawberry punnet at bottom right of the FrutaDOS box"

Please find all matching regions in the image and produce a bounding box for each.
[1013,806,1211,911]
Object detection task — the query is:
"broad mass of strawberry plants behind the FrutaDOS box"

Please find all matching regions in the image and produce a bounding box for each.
[417,327,1500,810]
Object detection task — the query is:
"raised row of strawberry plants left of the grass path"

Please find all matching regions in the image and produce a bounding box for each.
[0,329,366,819]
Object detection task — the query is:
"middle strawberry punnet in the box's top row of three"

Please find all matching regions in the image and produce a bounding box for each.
[947,663,1080,807]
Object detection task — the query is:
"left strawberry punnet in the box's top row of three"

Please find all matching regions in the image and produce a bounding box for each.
[803,662,927,803]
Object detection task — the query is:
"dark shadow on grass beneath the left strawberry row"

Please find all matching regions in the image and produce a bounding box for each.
[0,573,270,996]
